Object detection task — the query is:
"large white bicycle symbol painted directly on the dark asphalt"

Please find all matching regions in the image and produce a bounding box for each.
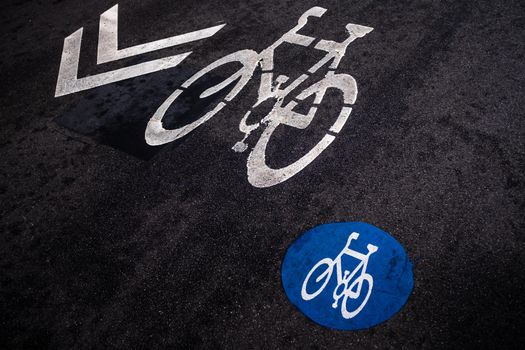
[145,7,373,187]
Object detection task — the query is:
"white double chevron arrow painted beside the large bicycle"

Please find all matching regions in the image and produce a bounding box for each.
[55,5,225,97]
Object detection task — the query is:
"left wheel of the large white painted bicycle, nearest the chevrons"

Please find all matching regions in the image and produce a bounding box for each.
[145,50,259,146]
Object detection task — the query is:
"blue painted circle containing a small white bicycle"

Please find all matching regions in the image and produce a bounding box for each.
[281,222,414,330]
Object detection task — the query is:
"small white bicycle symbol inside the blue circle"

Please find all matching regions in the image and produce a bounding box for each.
[301,232,378,319]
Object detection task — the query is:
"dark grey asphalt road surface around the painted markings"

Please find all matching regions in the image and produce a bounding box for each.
[0,0,525,349]
